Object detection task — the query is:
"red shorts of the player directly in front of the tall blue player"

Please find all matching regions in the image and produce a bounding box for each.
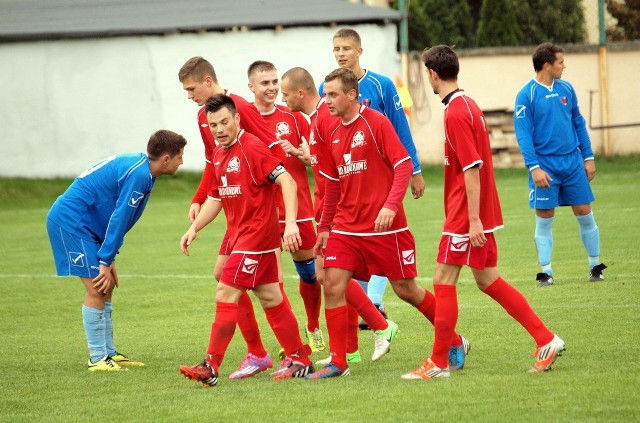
[324,230,418,281]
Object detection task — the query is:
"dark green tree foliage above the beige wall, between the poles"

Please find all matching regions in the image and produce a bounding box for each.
[395,0,588,50]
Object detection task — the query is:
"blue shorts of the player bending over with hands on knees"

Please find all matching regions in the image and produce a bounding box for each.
[47,219,100,279]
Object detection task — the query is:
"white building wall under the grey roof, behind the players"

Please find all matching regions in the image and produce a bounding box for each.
[0,25,400,177]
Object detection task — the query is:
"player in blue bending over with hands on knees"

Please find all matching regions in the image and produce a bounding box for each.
[47,130,187,372]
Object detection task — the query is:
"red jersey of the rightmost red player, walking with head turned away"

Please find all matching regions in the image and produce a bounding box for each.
[442,91,503,236]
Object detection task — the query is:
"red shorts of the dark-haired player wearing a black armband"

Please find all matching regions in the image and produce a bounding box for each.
[220,251,278,289]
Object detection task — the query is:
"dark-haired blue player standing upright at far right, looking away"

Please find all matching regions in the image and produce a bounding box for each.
[513,43,607,286]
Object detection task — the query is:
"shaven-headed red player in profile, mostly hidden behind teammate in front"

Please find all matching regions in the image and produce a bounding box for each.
[281,67,398,365]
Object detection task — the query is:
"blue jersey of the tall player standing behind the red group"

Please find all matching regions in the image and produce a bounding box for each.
[318,70,421,175]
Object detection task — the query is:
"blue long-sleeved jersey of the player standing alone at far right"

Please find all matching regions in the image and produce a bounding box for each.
[513,79,593,170]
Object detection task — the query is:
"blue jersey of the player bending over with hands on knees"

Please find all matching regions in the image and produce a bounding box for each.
[48,153,155,266]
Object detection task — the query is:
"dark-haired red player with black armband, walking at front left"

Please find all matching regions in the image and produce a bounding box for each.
[180,94,313,386]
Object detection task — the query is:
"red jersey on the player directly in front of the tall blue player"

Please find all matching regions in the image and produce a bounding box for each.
[320,106,411,236]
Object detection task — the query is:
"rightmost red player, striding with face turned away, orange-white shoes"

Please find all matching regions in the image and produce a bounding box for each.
[402,45,565,379]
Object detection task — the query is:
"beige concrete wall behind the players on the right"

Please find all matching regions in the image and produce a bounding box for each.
[410,43,640,163]
